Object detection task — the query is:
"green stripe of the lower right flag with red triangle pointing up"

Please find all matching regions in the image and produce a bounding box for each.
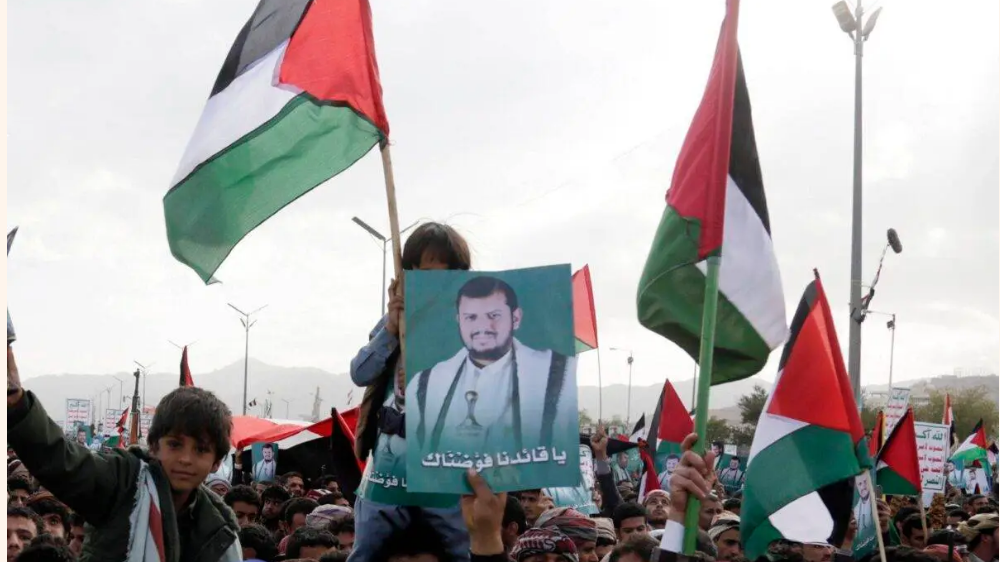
[740,420,861,560]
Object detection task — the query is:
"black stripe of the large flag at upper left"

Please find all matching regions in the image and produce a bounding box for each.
[212,0,311,96]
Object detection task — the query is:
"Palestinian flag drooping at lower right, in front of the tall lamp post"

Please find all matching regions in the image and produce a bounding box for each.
[740,274,871,560]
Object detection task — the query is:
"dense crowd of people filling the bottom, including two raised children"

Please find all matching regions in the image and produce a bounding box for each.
[7,223,1000,562]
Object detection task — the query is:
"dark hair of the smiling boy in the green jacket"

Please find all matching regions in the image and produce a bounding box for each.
[146,386,233,462]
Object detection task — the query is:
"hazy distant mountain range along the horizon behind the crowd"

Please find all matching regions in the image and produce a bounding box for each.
[19,359,1000,430]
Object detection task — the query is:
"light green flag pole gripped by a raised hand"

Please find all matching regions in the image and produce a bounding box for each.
[684,256,721,556]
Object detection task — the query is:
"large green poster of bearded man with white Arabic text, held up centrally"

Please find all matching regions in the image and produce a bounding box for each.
[405,265,580,494]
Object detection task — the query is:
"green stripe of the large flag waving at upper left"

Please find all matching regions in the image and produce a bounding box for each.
[163,94,381,282]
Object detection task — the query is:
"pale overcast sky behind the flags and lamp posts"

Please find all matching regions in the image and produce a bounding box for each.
[7,0,1000,396]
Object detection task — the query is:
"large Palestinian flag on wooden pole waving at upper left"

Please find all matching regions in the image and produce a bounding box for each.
[163,0,389,283]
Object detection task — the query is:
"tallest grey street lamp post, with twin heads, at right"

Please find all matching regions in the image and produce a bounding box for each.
[833,0,882,404]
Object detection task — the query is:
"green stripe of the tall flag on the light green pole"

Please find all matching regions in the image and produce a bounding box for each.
[637,206,771,385]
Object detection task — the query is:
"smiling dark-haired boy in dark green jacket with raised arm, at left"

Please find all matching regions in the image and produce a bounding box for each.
[7,344,243,562]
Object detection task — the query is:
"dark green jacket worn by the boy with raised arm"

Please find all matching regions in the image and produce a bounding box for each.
[7,391,242,562]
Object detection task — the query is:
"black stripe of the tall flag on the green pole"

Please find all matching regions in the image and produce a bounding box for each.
[729,51,771,235]
